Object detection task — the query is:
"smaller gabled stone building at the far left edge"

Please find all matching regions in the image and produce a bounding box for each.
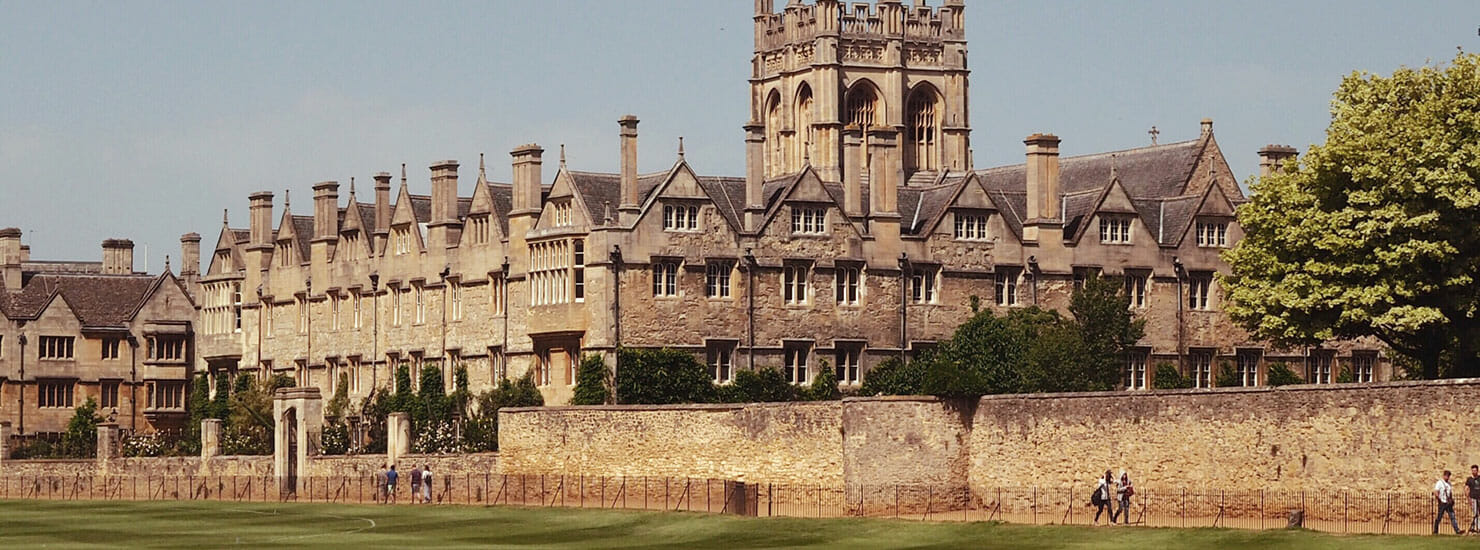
[0,228,200,435]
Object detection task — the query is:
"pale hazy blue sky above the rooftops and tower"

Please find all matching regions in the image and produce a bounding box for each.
[0,0,1480,271]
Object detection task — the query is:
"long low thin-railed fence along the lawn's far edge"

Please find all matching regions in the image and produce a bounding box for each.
[0,473,1476,535]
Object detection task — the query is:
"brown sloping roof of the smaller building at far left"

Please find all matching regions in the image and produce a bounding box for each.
[6,274,163,328]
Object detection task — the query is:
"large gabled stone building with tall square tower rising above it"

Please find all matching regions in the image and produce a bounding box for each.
[190,0,1391,404]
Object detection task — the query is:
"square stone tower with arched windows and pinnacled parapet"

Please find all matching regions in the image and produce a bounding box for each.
[746,0,971,204]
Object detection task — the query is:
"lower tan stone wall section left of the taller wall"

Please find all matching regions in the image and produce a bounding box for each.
[499,401,844,486]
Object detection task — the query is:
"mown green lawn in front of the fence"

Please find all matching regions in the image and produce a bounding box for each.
[0,501,1480,550]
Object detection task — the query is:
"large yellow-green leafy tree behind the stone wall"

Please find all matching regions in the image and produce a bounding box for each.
[1222,53,1480,378]
